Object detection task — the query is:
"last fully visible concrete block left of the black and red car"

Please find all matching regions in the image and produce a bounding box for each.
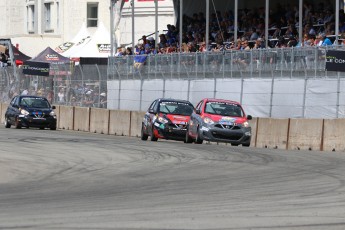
[109,110,131,136]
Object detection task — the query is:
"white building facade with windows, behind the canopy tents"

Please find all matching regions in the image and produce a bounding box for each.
[0,0,176,56]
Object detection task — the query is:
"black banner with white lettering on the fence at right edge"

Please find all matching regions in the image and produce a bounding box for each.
[326,50,345,72]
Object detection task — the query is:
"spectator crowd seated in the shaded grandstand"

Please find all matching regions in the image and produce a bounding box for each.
[116,0,345,56]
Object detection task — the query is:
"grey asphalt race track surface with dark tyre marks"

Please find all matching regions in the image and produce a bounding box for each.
[0,124,345,230]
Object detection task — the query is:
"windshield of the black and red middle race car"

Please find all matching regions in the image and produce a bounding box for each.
[159,101,193,116]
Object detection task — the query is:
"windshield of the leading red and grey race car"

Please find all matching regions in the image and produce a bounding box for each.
[205,102,243,117]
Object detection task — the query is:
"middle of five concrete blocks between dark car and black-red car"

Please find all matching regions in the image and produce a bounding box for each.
[90,108,109,134]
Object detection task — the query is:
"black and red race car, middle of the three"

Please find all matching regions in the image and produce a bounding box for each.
[141,98,194,141]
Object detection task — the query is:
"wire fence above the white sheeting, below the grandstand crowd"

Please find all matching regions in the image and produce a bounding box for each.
[109,47,338,80]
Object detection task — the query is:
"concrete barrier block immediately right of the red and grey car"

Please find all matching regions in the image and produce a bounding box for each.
[255,118,289,149]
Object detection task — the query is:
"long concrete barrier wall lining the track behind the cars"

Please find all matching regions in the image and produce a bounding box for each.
[0,103,345,152]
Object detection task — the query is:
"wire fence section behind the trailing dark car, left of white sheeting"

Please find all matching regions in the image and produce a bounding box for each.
[0,65,107,108]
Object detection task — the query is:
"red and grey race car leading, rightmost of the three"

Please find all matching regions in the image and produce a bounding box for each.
[185,98,252,146]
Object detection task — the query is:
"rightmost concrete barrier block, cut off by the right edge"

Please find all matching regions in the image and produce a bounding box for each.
[322,118,345,151]
